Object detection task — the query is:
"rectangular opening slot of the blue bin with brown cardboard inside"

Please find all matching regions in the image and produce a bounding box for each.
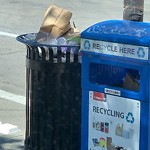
[89,63,140,91]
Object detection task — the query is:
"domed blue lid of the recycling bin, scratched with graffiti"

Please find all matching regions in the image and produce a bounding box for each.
[81,20,150,46]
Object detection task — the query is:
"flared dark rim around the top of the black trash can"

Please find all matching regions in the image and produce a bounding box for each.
[16,33,80,48]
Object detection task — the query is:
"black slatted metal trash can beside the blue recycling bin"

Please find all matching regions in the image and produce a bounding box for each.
[17,34,81,150]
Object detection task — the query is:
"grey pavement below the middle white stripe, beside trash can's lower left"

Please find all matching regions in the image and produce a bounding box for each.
[0,99,25,150]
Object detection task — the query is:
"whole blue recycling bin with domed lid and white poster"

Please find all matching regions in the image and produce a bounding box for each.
[81,20,150,150]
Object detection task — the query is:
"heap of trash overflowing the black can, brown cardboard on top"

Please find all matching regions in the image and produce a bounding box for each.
[35,5,80,62]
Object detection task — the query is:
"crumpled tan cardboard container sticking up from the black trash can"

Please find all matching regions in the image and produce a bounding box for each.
[36,5,72,42]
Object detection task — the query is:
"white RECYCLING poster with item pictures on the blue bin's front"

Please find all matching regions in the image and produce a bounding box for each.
[88,91,141,150]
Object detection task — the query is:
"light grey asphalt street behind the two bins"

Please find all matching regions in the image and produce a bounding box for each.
[0,0,150,150]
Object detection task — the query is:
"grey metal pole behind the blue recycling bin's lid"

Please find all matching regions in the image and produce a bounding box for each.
[123,0,144,21]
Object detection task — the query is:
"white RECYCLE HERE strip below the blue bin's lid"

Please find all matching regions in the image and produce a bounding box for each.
[81,38,149,60]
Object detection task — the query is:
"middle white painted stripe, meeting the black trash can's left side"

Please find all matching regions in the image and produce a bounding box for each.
[0,90,26,105]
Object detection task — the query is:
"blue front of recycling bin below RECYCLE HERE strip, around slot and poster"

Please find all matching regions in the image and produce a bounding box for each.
[81,51,150,150]
